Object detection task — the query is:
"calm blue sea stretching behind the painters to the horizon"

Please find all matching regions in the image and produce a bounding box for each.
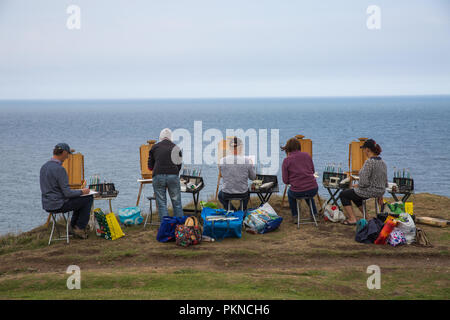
[0,96,450,234]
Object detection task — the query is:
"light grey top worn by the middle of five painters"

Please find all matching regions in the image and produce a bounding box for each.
[219,155,256,194]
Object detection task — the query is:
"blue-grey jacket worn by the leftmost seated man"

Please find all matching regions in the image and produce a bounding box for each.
[40,159,83,211]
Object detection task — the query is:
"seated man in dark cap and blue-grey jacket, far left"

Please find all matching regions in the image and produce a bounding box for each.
[40,143,94,239]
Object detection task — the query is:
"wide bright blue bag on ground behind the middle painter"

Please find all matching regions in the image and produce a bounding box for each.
[202,208,244,241]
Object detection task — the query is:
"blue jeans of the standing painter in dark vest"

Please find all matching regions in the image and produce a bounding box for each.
[153,174,184,221]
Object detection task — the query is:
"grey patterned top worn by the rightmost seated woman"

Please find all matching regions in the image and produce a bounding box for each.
[355,157,388,198]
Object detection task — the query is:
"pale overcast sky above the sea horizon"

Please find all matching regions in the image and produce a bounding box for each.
[0,0,450,100]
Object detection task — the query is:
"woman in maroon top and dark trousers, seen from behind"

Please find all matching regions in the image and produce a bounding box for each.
[281,138,319,223]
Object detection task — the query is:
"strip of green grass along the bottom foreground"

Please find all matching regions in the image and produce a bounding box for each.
[0,268,450,299]
